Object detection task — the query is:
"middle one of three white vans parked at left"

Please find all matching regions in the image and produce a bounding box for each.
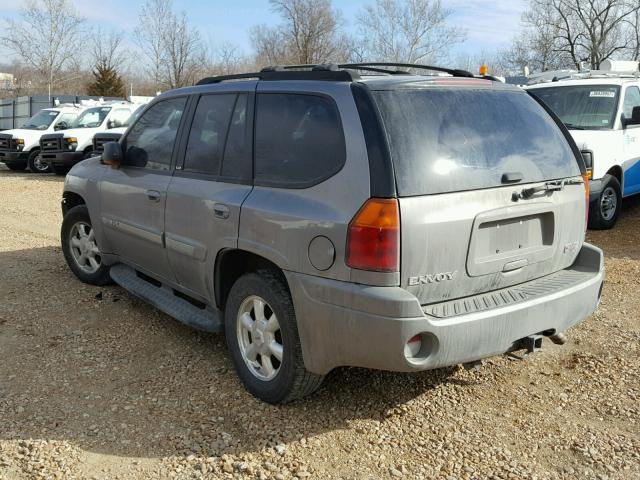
[40,101,140,175]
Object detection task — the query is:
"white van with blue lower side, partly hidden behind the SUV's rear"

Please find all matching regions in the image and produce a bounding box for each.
[526,61,640,229]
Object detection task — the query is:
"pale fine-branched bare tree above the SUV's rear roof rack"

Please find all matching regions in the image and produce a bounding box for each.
[357,0,465,63]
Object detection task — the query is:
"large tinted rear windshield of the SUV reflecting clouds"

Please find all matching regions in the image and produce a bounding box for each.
[373,87,580,196]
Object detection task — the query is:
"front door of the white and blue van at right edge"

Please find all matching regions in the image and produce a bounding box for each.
[622,86,640,197]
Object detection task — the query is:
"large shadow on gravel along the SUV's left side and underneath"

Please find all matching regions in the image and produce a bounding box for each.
[0,247,464,457]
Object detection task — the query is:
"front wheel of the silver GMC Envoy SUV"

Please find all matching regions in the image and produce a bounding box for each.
[60,205,112,285]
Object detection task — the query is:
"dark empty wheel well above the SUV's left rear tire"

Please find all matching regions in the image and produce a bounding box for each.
[214,250,286,310]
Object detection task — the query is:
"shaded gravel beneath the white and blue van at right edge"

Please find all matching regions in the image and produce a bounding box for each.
[587,195,640,260]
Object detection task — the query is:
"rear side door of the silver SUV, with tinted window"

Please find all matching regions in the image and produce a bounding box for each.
[166,87,255,299]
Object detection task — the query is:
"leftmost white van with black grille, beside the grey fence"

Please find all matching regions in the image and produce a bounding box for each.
[0,104,86,173]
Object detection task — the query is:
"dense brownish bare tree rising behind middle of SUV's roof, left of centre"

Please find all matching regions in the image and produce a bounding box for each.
[251,0,347,65]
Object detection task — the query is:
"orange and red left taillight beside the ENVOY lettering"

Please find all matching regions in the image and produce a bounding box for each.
[346,198,400,272]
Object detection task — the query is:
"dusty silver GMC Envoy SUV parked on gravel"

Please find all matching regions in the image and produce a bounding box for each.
[62,64,604,403]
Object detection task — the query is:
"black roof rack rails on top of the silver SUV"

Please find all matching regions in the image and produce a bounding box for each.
[196,62,475,85]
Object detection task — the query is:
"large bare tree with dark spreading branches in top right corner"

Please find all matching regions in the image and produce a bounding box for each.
[514,0,640,69]
